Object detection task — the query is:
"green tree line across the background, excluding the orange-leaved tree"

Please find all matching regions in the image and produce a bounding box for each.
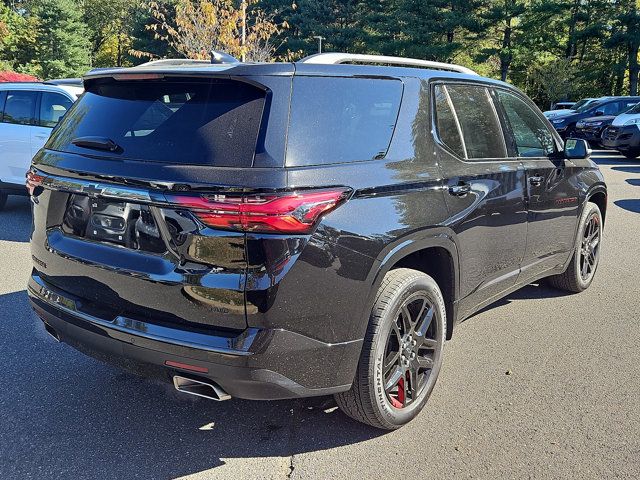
[0,0,640,106]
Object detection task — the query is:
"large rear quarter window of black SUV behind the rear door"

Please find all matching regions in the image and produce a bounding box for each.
[287,76,403,166]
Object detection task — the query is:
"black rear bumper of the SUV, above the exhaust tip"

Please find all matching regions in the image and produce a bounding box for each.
[28,274,362,400]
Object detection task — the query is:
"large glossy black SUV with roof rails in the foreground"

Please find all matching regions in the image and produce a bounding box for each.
[27,54,606,429]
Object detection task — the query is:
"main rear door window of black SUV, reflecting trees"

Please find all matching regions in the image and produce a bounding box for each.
[446,84,507,159]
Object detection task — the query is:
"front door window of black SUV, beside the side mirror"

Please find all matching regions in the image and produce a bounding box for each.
[498,90,555,157]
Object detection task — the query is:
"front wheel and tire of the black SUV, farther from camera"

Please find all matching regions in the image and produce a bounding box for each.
[547,202,602,293]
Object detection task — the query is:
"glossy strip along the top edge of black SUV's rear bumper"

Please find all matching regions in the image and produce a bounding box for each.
[27,275,258,356]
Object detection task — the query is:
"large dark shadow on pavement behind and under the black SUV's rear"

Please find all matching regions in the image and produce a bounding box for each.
[0,291,383,480]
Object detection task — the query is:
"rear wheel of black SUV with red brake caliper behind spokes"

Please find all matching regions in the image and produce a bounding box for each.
[335,268,446,430]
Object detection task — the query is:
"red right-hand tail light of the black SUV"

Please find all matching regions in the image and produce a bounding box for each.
[167,188,349,234]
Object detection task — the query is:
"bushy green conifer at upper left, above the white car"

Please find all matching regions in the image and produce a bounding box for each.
[31,0,90,79]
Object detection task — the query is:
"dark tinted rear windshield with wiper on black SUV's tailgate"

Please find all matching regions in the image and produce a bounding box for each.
[47,79,265,167]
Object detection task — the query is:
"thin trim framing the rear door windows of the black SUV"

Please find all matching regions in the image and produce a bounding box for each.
[429,78,510,163]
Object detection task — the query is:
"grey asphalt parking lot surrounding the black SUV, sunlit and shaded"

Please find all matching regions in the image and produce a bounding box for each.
[0,152,640,480]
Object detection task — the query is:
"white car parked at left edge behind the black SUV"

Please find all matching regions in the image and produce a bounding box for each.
[0,79,84,209]
